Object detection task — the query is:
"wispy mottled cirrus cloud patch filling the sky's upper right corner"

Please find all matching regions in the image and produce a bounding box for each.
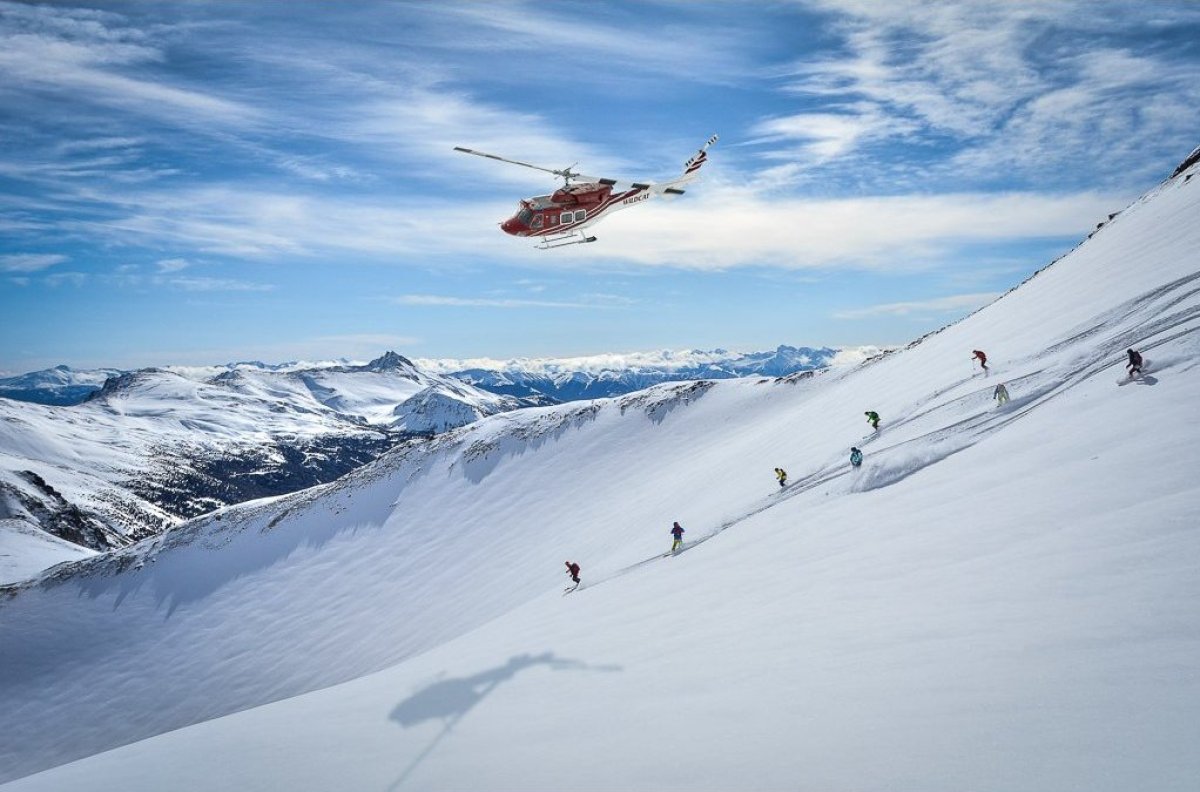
[754,0,1200,184]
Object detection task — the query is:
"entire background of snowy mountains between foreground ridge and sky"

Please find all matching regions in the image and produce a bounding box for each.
[0,346,874,571]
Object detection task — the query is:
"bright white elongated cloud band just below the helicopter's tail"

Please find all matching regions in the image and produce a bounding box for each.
[580,186,1129,270]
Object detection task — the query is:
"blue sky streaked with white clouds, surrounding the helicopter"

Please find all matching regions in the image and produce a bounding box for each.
[0,0,1200,372]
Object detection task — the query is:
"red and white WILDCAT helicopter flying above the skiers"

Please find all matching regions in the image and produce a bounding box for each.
[454,134,718,250]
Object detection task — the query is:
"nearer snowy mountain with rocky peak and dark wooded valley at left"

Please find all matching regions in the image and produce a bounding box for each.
[0,353,522,580]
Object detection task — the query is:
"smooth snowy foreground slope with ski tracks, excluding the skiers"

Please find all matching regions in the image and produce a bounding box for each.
[0,166,1200,792]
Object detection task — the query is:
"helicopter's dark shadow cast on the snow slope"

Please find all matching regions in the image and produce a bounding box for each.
[388,652,624,792]
